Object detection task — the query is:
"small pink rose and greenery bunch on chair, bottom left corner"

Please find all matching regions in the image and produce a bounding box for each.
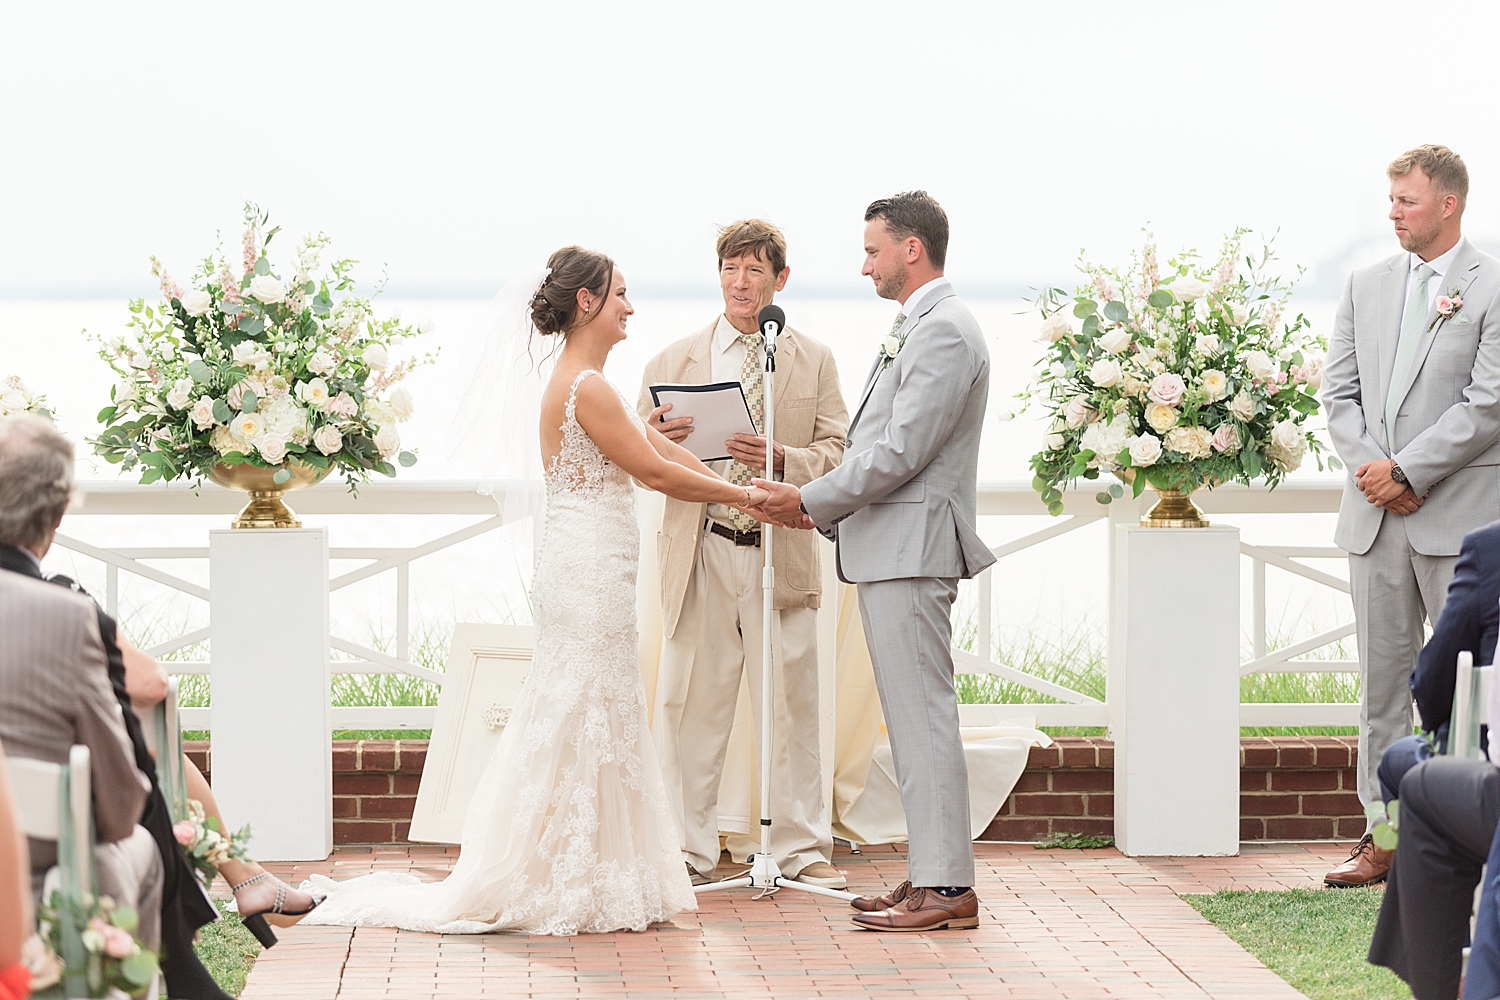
[21,892,158,997]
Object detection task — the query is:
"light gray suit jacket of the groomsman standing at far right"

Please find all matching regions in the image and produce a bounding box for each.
[1323,240,1500,556]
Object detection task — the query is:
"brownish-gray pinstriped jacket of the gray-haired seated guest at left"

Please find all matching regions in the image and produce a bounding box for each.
[0,570,150,873]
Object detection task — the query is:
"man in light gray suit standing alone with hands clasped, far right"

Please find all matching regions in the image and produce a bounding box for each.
[1323,145,1500,886]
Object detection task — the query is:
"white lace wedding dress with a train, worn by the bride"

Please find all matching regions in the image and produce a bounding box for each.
[303,370,696,936]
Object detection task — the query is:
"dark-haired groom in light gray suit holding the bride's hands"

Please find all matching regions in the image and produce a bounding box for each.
[755,190,995,931]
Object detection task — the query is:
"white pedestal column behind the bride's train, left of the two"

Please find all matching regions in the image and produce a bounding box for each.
[209,528,333,861]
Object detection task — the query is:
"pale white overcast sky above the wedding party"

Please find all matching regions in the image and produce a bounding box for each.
[0,0,1500,298]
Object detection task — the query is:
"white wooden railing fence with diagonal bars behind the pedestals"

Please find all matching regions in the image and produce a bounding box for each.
[57,481,1359,730]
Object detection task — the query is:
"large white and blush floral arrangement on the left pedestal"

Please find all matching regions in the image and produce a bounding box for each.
[92,204,434,489]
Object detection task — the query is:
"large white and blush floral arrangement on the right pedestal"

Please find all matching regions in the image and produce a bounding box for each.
[1022,229,1341,514]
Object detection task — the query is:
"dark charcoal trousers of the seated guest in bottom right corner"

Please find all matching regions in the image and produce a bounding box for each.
[1370,758,1500,1000]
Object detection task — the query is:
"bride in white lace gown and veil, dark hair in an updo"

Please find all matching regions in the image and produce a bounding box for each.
[303,246,767,936]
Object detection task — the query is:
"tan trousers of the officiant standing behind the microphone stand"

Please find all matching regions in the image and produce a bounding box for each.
[654,532,833,877]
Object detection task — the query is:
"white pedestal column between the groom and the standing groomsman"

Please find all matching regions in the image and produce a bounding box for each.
[1109,525,1239,856]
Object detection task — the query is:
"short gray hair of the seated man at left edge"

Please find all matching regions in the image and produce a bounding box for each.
[0,414,74,549]
